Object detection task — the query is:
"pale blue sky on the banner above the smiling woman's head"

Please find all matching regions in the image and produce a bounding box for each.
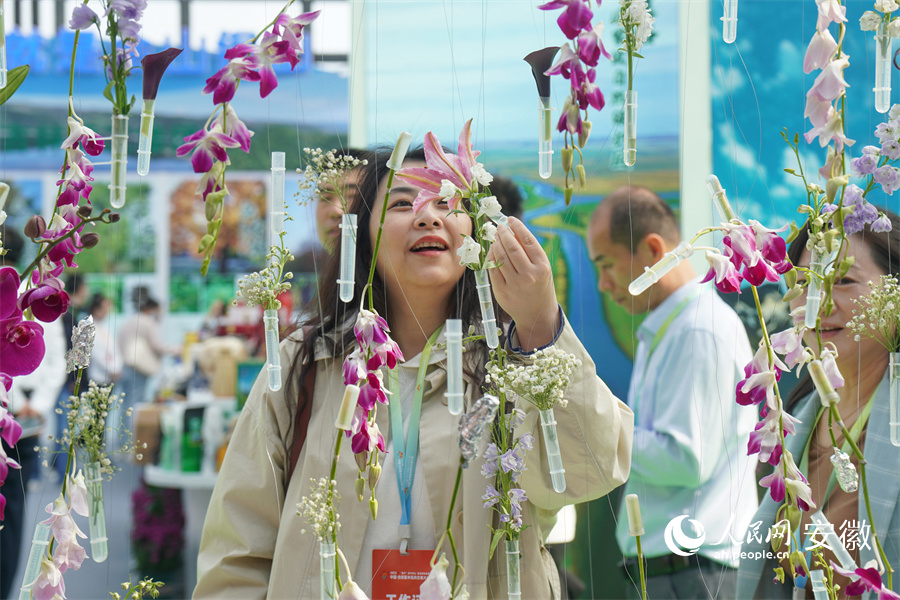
[365,0,678,150]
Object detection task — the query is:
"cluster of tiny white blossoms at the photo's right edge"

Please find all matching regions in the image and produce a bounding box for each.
[847,275,900,352]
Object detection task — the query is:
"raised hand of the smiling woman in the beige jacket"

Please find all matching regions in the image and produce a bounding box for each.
[488,217,559,352]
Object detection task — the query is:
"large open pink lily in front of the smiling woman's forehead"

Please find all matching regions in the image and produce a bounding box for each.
[397,119,481,212]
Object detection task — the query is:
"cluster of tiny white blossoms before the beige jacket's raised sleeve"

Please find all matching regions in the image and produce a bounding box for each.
[488,346,581,410]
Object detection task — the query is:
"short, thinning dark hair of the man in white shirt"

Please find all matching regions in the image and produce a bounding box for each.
[594,186,681,254]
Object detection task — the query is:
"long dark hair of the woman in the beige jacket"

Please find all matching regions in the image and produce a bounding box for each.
[284,148,486,440]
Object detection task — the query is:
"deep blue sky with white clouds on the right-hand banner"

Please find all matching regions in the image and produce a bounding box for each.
[710,2,900,227]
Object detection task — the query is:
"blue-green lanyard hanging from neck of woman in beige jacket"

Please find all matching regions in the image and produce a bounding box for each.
[388,327,442,525]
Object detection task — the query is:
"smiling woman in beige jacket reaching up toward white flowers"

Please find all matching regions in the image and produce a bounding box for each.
[194,145,633,598]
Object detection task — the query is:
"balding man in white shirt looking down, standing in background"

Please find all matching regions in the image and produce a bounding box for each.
[588,187,757,600]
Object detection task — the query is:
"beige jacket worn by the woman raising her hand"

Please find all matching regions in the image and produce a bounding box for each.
[194,322,633,599]
